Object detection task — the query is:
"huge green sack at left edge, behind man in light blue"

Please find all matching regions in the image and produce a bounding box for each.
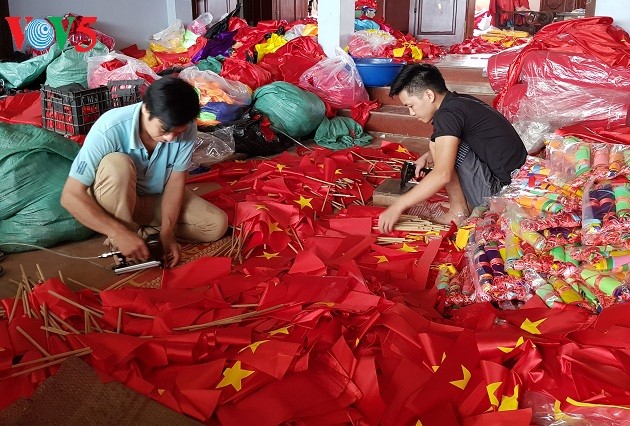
[0,123,94,253]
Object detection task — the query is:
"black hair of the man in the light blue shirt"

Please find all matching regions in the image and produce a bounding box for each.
[143,76,201,132]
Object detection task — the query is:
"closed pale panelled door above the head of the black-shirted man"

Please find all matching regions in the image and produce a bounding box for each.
[409,0,473,46]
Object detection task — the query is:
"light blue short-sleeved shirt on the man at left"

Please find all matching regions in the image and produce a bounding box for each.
[70,102,197,195]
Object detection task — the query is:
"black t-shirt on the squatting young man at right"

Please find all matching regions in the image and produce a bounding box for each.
[431,92,527,185]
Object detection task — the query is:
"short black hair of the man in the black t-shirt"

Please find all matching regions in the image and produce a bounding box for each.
[389,64,448,96]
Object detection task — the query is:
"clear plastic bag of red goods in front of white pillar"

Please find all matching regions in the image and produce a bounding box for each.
[299,47,370,109]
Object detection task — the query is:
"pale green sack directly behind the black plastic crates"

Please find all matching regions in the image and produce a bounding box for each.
[46,41,109,87]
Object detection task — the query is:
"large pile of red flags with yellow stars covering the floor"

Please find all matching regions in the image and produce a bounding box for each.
[0,144,630,425]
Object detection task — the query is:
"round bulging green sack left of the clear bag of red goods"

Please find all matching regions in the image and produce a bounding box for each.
[254,81,326,138]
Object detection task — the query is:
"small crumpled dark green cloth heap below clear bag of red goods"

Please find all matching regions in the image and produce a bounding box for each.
[315,117,372,150]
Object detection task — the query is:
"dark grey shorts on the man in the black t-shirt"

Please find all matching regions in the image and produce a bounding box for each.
[457,149,502,208]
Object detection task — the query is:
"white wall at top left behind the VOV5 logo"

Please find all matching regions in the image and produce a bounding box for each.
[9,0,192,50]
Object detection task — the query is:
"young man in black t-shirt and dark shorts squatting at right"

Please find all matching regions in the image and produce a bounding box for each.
[378,64,527,233]
